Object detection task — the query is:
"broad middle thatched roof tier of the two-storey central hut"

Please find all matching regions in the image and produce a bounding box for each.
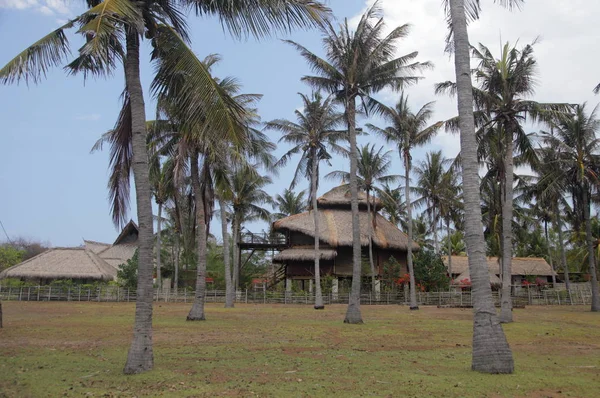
[273,209,419,250]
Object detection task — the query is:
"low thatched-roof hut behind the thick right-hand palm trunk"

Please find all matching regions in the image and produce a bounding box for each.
[443,256,556,286]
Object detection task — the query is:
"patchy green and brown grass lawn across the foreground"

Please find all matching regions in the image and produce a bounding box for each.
[0,302,600,397]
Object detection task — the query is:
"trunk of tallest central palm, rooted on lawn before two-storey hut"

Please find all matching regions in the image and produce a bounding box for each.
[344,96,363,324]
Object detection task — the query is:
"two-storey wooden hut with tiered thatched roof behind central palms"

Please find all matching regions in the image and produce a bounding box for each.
[273,186,419,290]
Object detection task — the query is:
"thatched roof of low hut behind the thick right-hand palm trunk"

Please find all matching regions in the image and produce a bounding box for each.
[443,256,554,276]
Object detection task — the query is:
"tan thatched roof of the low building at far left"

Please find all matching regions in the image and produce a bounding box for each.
[0,247,117,281]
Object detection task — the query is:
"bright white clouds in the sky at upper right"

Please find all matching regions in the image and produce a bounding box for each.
[350,0,600,161]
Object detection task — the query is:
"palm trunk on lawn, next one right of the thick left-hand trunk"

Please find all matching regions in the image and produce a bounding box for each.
[186,153,206,321]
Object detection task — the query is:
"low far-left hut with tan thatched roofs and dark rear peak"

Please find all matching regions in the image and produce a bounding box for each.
[0,221,138,284]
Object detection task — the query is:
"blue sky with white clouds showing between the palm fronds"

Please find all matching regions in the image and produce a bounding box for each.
[0,0,600,246]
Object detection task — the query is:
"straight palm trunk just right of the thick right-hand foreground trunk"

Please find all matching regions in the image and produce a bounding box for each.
[499,137,513,323]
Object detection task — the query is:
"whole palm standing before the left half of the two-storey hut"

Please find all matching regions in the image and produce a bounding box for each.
[266,92,345,309]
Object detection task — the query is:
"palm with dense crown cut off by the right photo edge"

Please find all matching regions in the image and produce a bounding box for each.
[541,104,600,312]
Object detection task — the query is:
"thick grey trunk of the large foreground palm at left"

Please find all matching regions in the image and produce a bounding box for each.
[123,30,154,374]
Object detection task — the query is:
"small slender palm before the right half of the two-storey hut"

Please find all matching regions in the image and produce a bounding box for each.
[326,144,399,292]
